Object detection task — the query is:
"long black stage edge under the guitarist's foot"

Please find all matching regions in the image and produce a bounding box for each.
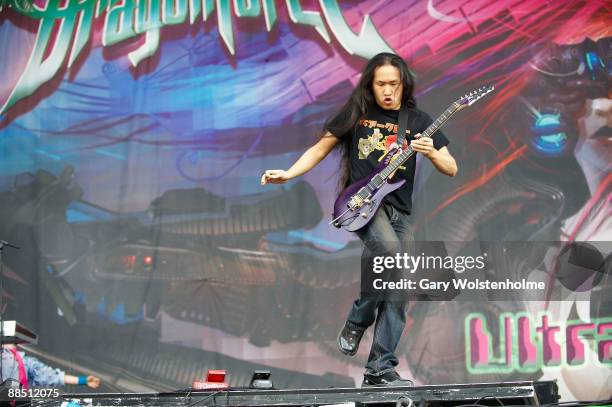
[31,381,559,407]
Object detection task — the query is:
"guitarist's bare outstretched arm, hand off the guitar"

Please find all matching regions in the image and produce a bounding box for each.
[261,132,340,185]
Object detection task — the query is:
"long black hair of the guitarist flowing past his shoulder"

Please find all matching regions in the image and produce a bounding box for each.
[323,52,416,188]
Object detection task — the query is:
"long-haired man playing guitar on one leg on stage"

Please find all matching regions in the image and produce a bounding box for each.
[261,53,457,386]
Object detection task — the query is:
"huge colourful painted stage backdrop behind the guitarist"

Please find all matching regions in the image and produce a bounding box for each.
[0,0,612,400]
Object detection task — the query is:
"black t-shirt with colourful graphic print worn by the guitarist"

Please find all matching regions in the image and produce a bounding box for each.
[332,104,449,213]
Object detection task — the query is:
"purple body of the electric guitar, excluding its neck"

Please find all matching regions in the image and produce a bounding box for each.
[333,162,406,232]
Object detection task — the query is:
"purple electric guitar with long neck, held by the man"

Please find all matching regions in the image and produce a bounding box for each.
[330,86,494,232]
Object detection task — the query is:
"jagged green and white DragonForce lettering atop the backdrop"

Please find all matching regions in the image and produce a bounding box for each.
[0,0,392,114]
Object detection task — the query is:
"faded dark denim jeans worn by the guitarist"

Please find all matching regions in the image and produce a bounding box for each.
[347,204,414,376]
